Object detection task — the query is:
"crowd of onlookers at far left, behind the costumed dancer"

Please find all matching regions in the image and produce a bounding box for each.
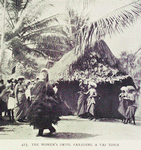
[0,76,36,122]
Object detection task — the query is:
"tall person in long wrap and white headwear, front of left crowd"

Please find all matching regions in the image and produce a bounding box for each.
[14,76,28,122]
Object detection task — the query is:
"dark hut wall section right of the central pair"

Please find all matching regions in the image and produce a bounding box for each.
[96,77,134,118]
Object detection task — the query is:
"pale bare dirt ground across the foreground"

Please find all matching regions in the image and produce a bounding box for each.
[0,116,141,140]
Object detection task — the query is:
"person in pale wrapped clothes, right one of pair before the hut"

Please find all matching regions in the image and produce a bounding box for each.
[85,82,97,119]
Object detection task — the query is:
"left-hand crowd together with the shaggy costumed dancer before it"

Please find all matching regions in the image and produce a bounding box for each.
[0,68,62,136]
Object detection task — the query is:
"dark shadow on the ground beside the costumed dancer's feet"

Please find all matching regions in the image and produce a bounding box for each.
[43,132,100,139]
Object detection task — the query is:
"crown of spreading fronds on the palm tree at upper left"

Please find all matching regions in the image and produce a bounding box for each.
[0,0,69,75]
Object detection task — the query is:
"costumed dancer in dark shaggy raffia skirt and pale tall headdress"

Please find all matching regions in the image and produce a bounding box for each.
[27,68,60,136]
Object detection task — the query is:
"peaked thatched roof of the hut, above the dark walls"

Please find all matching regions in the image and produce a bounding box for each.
[49,40,125,82]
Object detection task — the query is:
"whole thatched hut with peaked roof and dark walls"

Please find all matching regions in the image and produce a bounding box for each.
[49,40,134,118]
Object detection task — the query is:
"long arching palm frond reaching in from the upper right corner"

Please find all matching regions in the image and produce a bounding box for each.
[76,0,141,54]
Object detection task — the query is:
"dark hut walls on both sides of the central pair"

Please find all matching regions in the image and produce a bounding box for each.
[58,77,134,118]
